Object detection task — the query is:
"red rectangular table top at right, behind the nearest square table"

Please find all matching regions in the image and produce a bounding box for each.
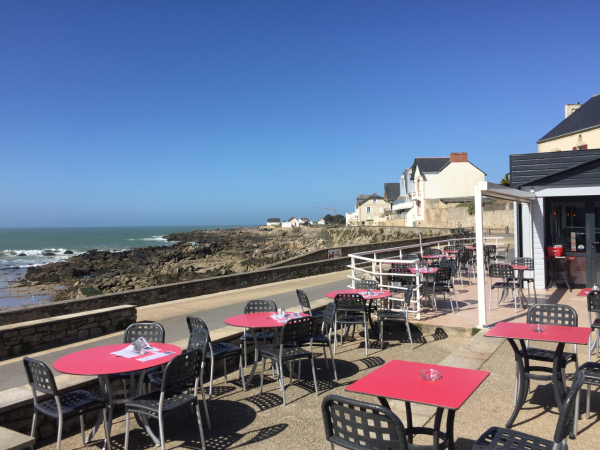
[485,322,592,344]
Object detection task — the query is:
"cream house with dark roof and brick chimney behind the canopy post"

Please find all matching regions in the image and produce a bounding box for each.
[406,153,485,227]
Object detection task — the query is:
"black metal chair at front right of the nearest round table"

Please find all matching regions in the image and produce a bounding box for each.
[124,348,206,450]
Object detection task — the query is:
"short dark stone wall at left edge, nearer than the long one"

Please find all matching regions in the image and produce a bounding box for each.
[0,302,137,359]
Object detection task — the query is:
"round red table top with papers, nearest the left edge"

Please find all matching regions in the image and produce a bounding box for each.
[53,343,182,375]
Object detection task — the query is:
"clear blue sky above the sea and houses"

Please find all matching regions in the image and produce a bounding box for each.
[0,0,600,227]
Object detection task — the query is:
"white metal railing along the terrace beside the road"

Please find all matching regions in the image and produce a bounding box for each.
[348,234,496,320]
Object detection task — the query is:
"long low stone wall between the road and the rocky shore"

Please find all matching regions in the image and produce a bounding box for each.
[0,259,349,326]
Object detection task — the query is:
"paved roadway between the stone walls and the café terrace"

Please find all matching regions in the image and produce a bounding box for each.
[0,271,349,391]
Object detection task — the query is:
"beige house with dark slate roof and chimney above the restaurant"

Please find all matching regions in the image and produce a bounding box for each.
[537,95,600,153]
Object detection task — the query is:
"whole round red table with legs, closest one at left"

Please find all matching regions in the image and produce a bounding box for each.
[53,342,181,445]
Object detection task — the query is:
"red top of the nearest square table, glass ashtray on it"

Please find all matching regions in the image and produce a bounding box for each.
[346,360,490,409]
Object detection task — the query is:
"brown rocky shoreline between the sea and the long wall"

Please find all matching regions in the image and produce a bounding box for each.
[13,227,438,301]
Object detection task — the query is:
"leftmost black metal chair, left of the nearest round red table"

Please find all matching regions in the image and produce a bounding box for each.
[22,357,110,450]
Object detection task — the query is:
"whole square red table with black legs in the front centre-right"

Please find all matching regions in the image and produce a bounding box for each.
[346,360,489,450]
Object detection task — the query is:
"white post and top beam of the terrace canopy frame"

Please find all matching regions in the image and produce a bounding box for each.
[475,181,535,328]
